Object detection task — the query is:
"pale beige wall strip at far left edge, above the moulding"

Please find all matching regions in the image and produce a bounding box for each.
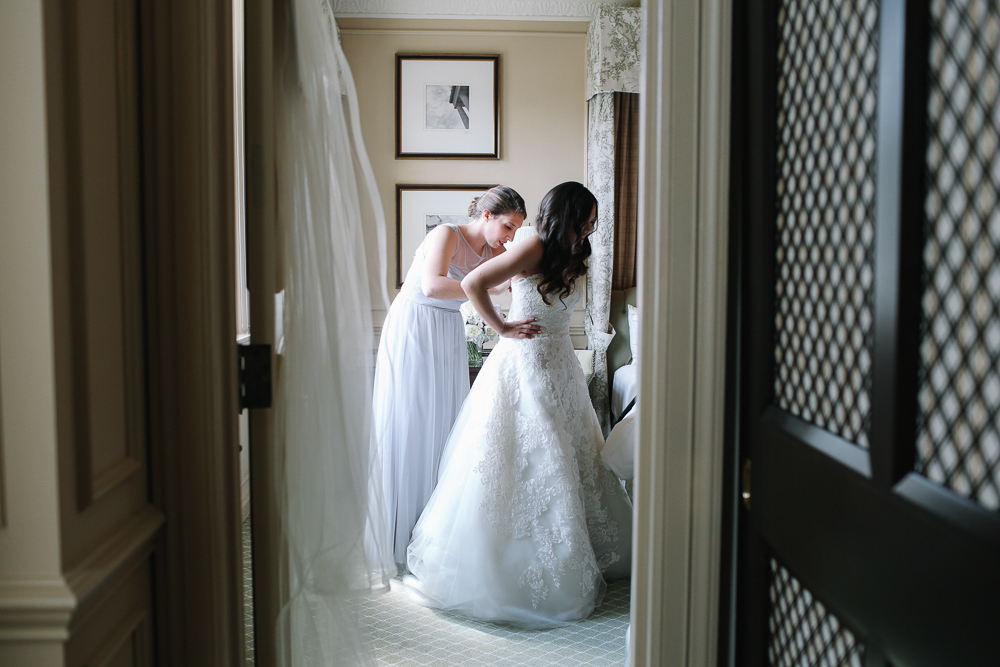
[0,0,62,596]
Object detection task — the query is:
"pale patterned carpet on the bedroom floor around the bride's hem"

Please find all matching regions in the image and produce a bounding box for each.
[243,519,629,667]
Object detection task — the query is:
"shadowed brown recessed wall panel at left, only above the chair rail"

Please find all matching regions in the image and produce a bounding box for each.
[49,0,148,570]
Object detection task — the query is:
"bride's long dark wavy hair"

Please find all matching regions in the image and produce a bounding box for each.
[535,181,597,304]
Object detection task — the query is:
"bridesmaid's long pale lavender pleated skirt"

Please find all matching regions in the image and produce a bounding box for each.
[372,294,469,570]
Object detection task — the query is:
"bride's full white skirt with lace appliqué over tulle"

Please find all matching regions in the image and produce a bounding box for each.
[404,336,632,629]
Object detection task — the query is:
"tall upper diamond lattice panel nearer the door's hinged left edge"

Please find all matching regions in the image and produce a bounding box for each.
[774,0,878,447]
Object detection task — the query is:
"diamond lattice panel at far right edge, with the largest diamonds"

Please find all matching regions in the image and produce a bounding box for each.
[917,0,1000,510]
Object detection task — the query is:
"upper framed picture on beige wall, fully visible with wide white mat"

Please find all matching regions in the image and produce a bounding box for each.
[396,54,500,160]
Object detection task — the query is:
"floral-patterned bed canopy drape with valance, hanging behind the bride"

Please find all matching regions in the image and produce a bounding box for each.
[584,5,641,436]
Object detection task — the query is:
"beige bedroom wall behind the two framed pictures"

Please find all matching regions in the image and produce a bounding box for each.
[338,19,587,336]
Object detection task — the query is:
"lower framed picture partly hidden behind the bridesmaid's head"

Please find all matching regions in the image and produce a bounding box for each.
[396,185,493,289]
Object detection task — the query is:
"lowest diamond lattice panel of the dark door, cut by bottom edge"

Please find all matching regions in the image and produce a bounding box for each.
[767,558,865,667]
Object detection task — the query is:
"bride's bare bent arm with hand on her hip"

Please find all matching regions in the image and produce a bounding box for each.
[462,236,542,338]
